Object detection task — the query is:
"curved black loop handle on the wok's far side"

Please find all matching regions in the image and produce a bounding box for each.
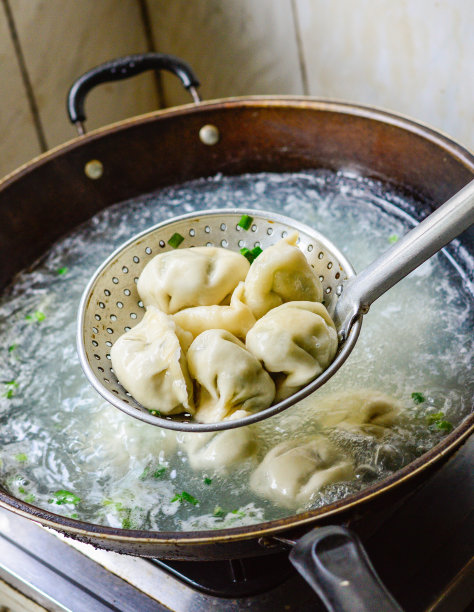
[67,53,200,134]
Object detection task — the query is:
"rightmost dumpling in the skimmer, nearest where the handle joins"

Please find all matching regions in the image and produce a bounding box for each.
[245,302,338,400]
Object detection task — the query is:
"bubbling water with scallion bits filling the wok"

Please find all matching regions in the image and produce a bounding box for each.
[0,171,474,531]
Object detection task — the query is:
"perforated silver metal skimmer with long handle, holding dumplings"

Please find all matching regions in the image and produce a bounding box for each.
[77,181,474,432]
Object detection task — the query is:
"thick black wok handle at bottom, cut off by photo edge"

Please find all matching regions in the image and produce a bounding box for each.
[290,526,402,612]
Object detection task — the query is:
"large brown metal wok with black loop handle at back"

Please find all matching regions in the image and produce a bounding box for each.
[0,54,474,610]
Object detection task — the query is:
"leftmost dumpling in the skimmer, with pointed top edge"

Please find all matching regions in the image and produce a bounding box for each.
[110,306,194,414]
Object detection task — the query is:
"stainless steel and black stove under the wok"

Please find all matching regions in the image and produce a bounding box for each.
[0,438,474,612]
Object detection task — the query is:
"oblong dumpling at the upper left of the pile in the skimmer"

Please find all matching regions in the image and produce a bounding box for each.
[137,247,250,314]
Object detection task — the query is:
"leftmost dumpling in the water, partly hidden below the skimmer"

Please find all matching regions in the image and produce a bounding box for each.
[179,426,257,472]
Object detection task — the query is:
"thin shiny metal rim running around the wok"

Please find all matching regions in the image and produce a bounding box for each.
[0,96,474,546]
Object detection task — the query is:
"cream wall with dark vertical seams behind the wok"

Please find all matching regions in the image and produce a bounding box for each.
[0,0,474,176]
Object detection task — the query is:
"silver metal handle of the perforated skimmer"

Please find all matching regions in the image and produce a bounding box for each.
[334,181,474,339]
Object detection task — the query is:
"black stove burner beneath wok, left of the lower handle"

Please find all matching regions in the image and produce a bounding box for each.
[151,552,296,598]
